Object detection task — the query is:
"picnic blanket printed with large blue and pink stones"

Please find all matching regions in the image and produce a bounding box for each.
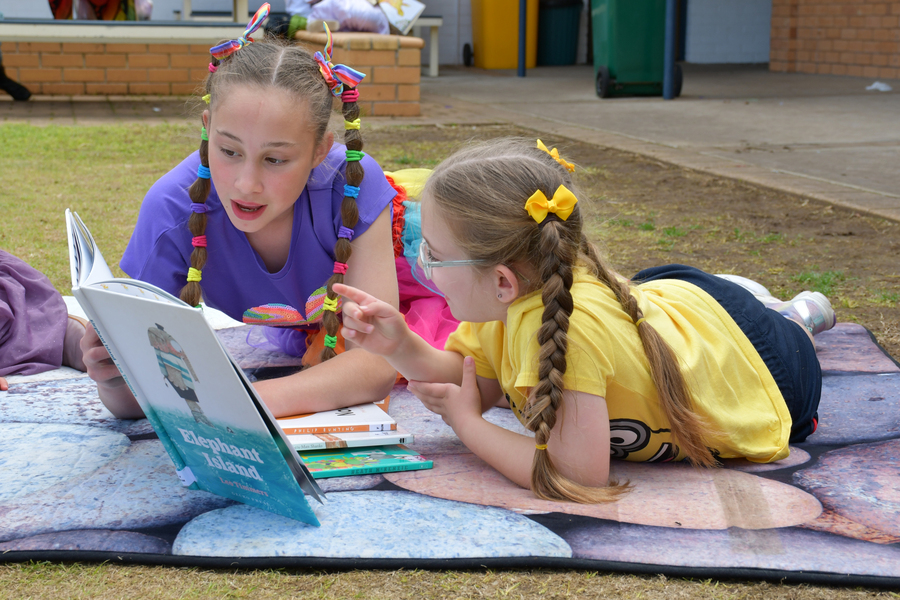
[0,324,900,586]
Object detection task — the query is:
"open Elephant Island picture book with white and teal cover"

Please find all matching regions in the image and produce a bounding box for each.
[66,210,325,525]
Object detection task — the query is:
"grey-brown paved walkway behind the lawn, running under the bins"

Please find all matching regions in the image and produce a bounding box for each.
[0,65,900,220]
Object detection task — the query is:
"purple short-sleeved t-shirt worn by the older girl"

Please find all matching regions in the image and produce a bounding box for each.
[119,144,396,352]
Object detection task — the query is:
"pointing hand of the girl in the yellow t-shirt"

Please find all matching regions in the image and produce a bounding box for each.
[334,283,410,356]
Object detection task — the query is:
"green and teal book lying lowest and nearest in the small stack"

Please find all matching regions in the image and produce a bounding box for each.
[299,446,434,479]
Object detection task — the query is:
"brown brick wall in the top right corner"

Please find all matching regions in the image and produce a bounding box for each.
[769,0,900,79]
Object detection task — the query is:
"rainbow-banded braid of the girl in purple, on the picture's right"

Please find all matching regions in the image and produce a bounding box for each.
[321,89,365,362]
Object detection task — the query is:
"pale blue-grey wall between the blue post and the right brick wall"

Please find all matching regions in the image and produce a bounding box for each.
[684,0,777,64]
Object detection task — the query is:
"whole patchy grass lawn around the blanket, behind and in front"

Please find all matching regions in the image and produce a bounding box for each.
[0,124,900,599]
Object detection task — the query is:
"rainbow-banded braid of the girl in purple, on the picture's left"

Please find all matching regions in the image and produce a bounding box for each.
[180,58,219,306]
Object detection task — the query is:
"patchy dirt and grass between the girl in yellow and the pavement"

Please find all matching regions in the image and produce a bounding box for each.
[366,126,900,359]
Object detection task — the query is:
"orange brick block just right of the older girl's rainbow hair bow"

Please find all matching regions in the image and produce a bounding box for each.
[296,31,424,117]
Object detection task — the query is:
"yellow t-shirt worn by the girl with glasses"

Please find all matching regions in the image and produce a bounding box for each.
[446,269,791,462]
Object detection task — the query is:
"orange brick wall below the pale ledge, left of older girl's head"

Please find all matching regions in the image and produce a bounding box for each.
[0,42,209,96]
